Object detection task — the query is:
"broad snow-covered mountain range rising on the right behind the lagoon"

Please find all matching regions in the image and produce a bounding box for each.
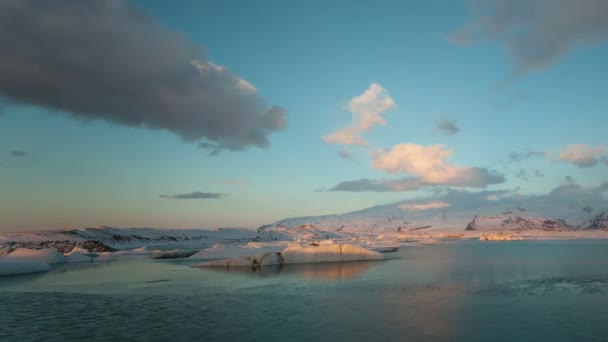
[258,191,608,236]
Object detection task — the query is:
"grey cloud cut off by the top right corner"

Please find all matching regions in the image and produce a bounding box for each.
[448,0,608,77]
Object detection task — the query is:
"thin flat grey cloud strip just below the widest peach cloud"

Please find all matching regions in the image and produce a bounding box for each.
[329,178,429,192]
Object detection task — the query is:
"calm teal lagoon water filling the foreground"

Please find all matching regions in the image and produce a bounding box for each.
[0,240,608,342]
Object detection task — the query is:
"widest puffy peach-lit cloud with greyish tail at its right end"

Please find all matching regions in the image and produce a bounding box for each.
[373,143,505,188]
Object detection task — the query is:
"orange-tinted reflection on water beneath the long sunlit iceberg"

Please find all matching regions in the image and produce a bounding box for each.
[199,261,378,280]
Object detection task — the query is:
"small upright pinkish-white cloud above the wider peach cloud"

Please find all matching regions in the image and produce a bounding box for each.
[323,83,395,146]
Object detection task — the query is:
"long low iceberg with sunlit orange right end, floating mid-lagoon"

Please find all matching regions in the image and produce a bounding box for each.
[196,244,385,267]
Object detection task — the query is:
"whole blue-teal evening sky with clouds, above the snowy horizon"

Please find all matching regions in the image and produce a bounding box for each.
[0,0,608,231]
